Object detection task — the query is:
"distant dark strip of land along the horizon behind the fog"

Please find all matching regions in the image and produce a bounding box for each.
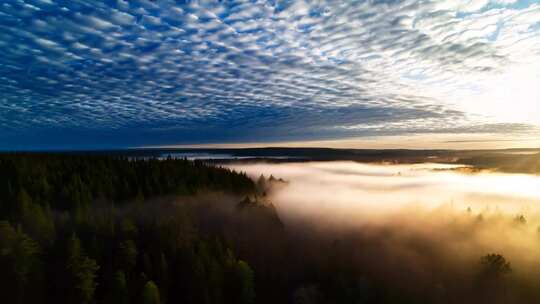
[116,147,540,174]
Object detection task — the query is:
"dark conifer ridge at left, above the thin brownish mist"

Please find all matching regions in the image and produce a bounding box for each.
[0,154,255,215]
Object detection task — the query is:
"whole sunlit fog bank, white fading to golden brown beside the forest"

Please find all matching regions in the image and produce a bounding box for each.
[228,162,540,277]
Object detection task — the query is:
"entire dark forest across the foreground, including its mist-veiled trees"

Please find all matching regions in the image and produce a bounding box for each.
[0,154,539,304]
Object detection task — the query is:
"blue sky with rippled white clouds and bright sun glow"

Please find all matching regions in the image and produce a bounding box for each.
[0,0,540,150]
